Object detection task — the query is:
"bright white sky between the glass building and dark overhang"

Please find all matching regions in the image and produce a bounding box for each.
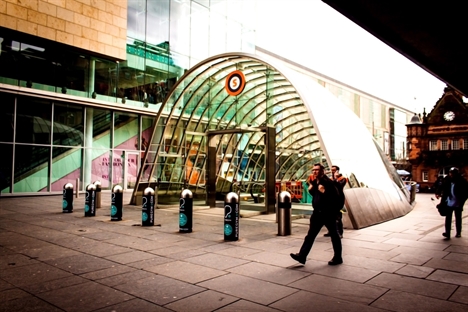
[257,0,446,113]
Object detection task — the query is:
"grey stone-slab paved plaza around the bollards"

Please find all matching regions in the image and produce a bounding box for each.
[0,192,468,312]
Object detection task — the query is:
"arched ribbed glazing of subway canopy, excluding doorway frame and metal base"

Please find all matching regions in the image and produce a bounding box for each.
[133,53,407,225]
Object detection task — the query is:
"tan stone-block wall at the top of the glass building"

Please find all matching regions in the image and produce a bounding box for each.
[0,0,127,60]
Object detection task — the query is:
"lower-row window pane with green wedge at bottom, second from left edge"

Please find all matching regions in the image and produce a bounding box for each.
[13,144,50,193]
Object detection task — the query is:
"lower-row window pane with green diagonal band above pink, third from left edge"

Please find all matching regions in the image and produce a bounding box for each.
[50,147,83,192]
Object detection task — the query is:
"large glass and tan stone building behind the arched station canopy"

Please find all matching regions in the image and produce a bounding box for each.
[0,0,255,195]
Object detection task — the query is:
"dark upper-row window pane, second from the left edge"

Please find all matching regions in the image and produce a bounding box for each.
[16,97,52,144]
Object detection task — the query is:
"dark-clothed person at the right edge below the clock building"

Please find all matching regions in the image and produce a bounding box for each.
[435,167,468,240]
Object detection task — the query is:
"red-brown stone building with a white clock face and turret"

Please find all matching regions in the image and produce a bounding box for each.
[406,87,468,191]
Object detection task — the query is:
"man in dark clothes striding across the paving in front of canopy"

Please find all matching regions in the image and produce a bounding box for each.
[291,164,343,265]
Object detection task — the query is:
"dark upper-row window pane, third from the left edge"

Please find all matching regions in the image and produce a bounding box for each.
[52,104,84,146]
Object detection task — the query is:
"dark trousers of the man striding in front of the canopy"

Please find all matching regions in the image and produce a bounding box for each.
[299,210,342,260]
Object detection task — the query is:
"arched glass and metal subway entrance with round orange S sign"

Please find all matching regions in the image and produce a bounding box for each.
[131,53,412,228]
